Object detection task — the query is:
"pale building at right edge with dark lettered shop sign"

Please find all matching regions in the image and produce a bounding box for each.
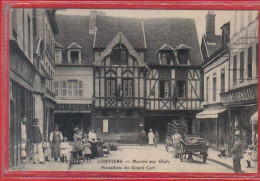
[220,11,259,151]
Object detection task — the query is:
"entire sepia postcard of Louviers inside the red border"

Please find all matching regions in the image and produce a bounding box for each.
[8,8,259,173]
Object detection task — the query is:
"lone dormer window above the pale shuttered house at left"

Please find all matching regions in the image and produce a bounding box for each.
[68,43,82,64]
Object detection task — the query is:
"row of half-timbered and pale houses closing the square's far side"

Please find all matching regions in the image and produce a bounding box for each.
[55,11,203,143]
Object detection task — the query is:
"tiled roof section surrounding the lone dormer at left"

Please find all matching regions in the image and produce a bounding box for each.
[55,15,94,65]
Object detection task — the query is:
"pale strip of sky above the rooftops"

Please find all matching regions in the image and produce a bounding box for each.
[56,9,234,42]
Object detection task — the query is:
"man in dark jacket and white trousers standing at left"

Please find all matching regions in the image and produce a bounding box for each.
[31,119,45,164]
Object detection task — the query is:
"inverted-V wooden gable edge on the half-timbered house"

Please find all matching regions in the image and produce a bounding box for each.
[95,32,148,69]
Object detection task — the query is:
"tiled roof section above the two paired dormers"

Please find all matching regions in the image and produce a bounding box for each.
[144,18,202,65]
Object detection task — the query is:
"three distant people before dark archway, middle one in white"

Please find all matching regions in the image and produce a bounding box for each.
[139,129,159,147]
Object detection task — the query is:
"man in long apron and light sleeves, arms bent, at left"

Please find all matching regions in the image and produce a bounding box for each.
[50,125,63,162]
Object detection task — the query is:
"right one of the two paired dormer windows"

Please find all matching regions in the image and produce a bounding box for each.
[175,44,190,65]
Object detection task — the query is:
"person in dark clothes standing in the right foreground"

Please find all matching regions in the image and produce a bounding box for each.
[231,131,243,173]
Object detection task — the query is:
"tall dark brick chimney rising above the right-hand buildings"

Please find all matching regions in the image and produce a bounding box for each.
[206,11,216,43]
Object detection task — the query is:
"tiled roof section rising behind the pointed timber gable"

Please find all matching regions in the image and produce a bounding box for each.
[94,15,145,49]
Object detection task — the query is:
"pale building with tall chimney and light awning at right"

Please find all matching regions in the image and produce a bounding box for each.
[199,11,230,150]
